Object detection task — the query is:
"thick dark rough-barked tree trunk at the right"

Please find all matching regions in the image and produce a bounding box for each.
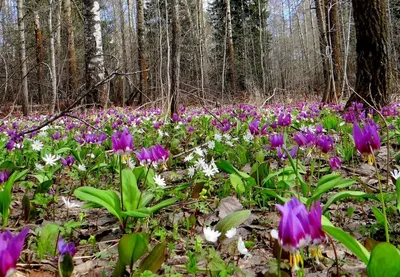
[346,0,390,109]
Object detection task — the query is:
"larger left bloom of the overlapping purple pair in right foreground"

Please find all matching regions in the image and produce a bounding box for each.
[276,197,311,253]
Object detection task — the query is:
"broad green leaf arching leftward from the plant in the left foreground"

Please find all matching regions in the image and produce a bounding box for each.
[74,187,122,222]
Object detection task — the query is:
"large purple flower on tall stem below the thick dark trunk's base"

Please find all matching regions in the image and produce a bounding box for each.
[353,123,381,154]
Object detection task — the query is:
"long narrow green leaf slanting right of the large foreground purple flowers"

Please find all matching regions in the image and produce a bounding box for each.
[322,222,369,264]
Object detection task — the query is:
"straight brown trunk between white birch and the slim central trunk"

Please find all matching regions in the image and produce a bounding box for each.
[137,0,148,105]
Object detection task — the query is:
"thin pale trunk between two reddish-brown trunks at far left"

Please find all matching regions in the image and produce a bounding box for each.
[48,0,57,114]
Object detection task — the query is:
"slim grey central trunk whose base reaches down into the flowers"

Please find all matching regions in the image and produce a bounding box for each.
[171,0,181,117]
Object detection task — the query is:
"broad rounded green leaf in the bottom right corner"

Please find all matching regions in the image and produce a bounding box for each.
[367,242,400,277]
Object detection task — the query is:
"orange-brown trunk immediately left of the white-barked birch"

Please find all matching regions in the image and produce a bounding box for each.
[64,0,78,95]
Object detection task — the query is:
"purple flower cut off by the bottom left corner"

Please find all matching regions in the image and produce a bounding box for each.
[0,228,29,277]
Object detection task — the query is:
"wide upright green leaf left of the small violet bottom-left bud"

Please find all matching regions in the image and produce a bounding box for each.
[37,223,58,259]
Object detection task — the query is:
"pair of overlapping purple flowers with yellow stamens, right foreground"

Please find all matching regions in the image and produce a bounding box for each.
[275,197,326,267]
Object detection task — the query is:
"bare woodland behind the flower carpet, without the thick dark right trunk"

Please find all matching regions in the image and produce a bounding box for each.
[0,0,400,114]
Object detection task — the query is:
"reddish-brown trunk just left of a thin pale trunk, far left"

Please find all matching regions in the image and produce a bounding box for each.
[33,10,44,104]
